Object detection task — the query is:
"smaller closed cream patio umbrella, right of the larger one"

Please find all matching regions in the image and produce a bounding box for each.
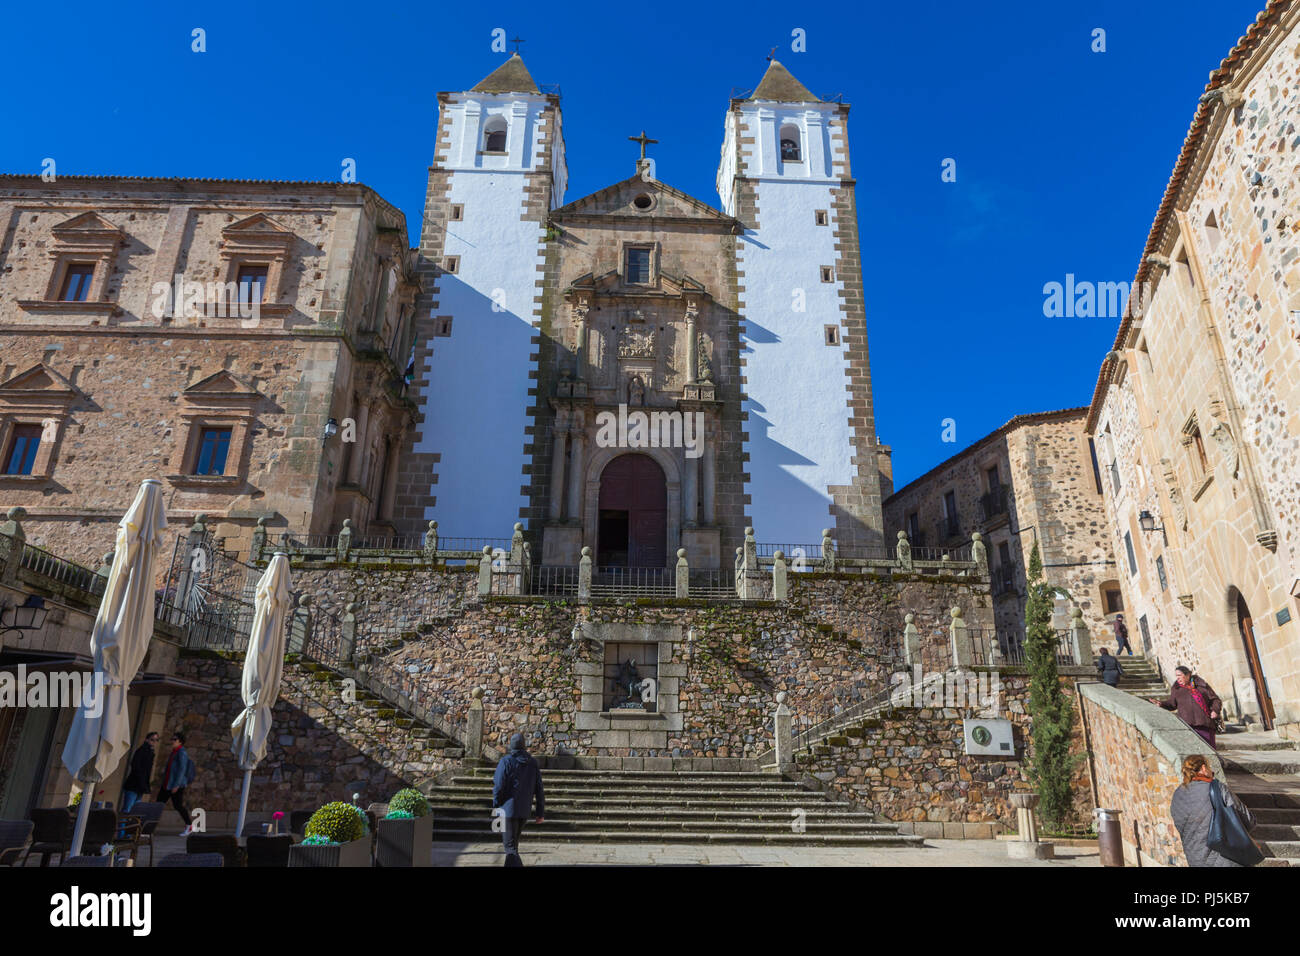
[230,551,290,836]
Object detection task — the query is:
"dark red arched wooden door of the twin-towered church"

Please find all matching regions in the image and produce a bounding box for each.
[595,455,668,567]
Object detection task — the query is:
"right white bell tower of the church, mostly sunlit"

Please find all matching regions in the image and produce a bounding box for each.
[718,60,884,546]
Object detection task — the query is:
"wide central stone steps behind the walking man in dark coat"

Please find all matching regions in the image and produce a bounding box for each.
[425,769,924,847]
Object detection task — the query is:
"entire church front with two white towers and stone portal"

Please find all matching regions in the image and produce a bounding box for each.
[399,55,888,568]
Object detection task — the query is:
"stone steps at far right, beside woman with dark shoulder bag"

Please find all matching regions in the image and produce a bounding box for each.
[1218,731,1300,866]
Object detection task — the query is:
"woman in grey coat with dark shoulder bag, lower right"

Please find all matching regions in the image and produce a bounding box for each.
[1169,753,1264,866]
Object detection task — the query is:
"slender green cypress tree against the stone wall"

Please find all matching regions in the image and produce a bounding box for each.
[1024,542,1076,831]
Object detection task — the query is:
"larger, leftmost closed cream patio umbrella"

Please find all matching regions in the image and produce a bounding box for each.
[64,479,166,856]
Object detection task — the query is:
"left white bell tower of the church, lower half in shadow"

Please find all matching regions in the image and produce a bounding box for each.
[398,52,567,537]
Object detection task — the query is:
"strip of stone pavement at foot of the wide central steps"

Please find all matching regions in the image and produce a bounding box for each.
[433,832,1101,866]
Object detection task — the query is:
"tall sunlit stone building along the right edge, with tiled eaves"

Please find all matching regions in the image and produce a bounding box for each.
[1087,1,1300,735]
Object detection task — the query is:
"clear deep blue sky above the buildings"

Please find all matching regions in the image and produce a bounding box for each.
[0,0,1264,486]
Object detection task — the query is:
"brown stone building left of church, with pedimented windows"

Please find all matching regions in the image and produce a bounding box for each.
[0,176,416,567]
